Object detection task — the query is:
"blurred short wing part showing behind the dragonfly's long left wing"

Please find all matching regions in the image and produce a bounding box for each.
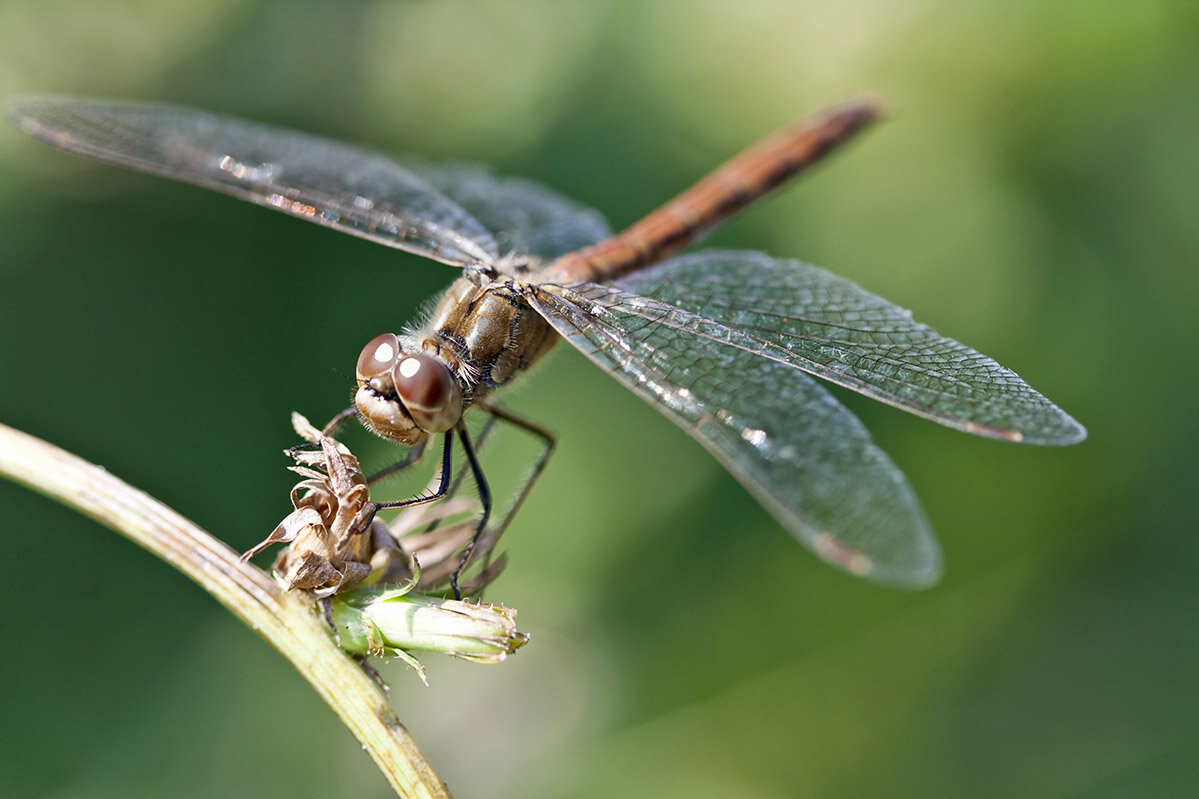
[402,160,611,263]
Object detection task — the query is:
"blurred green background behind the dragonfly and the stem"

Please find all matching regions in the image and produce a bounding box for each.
[0,0,1199,798]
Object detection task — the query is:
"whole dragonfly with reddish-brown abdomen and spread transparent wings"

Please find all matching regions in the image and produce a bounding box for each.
[10,98,1086,588]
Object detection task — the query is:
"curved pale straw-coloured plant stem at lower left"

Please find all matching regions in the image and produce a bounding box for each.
[0,425,450,799]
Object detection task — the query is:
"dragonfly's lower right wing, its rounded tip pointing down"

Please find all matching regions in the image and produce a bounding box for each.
[530,279,941,587]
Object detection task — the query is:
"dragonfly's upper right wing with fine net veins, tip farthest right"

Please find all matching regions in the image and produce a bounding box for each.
[573,250,1086,444]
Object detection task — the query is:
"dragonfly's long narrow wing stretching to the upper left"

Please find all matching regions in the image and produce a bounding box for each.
[8,98,499,265]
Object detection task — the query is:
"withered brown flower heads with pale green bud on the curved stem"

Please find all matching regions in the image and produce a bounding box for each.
[242,414,529,680]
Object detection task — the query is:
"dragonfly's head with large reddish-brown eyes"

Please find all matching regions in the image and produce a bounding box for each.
[354,334,463,444]
